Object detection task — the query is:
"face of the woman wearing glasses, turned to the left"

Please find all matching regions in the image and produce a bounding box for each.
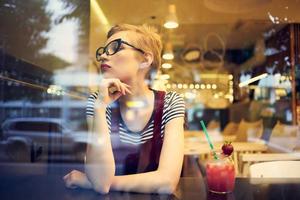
[100,31,142,82]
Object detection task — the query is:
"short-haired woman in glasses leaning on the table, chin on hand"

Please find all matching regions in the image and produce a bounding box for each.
[64,24,185,194]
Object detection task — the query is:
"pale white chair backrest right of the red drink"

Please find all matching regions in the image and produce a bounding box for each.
[249,161,300,178]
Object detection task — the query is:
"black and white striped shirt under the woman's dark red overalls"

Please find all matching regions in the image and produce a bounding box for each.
[86,92,185,144]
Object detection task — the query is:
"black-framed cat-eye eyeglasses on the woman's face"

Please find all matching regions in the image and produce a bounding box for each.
[96,39,145,61]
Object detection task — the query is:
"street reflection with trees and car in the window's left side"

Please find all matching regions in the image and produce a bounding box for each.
[0,0,89,163]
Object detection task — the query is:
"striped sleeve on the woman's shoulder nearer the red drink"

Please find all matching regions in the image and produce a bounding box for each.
[163,92,185,124]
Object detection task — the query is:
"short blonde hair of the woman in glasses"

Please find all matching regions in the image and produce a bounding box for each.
[107,24,162,71]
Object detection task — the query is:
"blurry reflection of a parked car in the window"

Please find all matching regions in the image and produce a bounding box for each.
[2,117,87,161]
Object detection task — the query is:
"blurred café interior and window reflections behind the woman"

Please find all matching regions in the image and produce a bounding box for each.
[0,0,300,199]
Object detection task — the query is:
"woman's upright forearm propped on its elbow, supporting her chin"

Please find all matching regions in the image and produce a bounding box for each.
[85,106,115,193]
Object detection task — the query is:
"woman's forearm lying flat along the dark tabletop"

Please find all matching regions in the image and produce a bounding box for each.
[110,171,179,194]
